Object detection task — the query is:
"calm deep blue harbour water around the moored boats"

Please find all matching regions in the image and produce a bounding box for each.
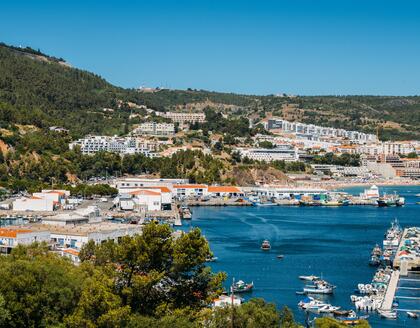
[184,186,420,327]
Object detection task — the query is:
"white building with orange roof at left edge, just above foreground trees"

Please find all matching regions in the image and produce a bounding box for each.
[0,228,50,254]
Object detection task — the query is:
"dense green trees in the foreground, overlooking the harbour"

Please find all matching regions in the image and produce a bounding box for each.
[0,223,308,328]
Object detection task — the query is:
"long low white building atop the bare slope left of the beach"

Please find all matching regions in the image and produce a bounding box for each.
[237,145,299,162]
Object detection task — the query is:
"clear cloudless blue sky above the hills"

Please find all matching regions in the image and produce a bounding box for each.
[0,0,420,95]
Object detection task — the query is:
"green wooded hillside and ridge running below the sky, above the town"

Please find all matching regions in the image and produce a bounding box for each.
[0,44,420,140]
